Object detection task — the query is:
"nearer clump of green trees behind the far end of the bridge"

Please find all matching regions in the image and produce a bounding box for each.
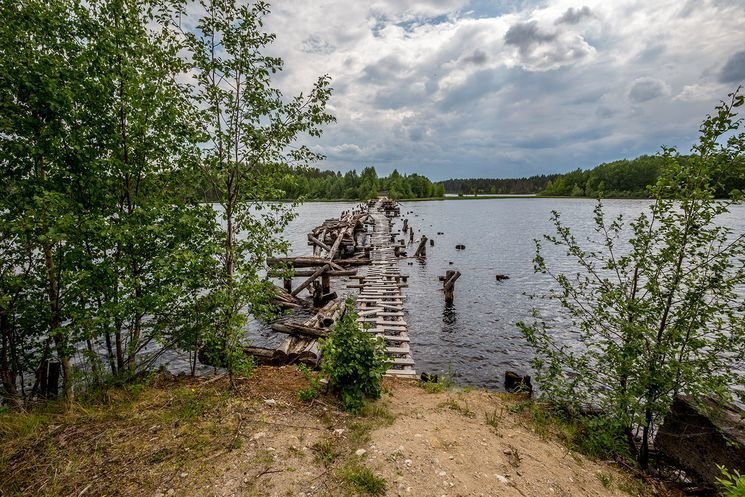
[268,167,445,200]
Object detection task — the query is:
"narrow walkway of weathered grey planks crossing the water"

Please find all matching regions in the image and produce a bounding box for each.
[349,199,416,377]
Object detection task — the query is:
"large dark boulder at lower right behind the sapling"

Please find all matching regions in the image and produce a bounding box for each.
[655,396,745,486]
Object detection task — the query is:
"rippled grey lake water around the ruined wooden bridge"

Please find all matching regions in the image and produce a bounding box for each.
[251,198,745,388]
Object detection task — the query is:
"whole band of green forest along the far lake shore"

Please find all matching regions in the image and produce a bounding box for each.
[254,151,745,202]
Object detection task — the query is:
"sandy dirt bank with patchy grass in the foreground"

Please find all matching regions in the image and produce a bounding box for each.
[0,367,664,497]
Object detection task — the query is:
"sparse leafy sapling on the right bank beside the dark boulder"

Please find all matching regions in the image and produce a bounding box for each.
[519,89,745,468]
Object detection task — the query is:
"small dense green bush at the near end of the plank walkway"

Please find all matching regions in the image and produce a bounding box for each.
[321,299,388,412]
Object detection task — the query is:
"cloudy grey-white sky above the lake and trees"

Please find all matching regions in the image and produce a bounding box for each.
[258,0,745,180]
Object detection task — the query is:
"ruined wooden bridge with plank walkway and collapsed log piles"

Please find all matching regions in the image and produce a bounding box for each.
[234,198,416,377]
